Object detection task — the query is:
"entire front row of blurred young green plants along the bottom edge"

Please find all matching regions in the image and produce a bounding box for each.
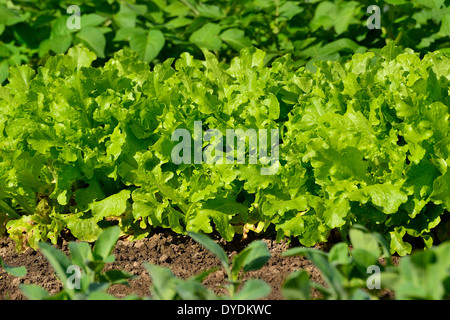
[0,225,450,300]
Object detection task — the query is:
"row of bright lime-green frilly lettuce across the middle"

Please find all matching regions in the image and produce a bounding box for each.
[0,43,450,255]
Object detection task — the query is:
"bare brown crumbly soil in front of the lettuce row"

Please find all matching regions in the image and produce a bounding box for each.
[0,232,322,300]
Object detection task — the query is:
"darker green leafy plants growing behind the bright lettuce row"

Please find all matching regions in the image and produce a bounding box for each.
[0,0,450,83]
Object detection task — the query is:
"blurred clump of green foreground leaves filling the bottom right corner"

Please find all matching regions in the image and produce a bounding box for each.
[282,226,450,300]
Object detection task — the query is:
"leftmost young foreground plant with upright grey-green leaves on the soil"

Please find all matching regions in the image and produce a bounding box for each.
[20,226,134,300]
